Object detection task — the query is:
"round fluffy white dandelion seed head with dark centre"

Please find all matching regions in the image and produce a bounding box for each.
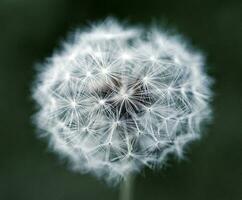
[33,19,211,184]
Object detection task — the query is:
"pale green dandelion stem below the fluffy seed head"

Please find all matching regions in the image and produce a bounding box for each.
[120,175,134,200]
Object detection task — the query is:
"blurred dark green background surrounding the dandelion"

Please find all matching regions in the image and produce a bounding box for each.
[0,0,242,200]
